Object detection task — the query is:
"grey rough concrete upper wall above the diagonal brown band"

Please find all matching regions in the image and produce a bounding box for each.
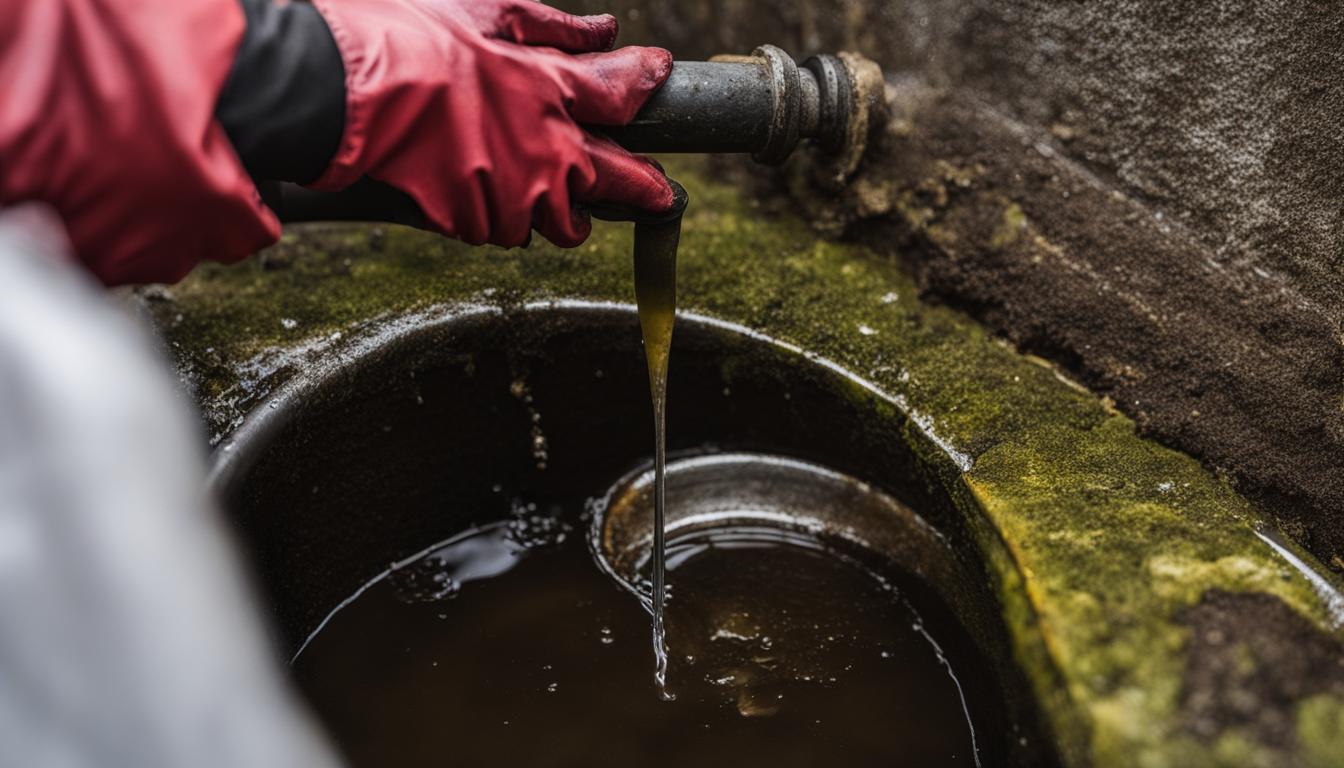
[560,0,1344,293]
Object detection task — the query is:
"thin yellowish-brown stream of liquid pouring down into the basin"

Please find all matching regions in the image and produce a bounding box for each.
[634,203,684,701]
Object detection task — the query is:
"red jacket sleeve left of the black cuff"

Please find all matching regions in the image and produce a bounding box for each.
[0,0,280,285]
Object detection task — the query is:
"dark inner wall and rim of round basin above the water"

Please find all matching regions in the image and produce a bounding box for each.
[212,303,1055,765]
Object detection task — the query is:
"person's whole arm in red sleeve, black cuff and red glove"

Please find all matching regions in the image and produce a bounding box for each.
[0,0,672,284]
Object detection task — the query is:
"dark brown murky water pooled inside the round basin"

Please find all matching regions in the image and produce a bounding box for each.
[293,518,1004,768]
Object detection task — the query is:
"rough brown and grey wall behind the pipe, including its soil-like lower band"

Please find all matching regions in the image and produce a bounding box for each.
[564,0,1344,570]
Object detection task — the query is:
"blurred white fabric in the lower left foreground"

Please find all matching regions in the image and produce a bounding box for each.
[0,206,336,768]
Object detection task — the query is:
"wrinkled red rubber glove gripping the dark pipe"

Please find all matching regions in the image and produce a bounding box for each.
[313,0,672,246]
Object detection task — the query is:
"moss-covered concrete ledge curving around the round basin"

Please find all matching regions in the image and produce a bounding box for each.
[140,160,1344,768]
